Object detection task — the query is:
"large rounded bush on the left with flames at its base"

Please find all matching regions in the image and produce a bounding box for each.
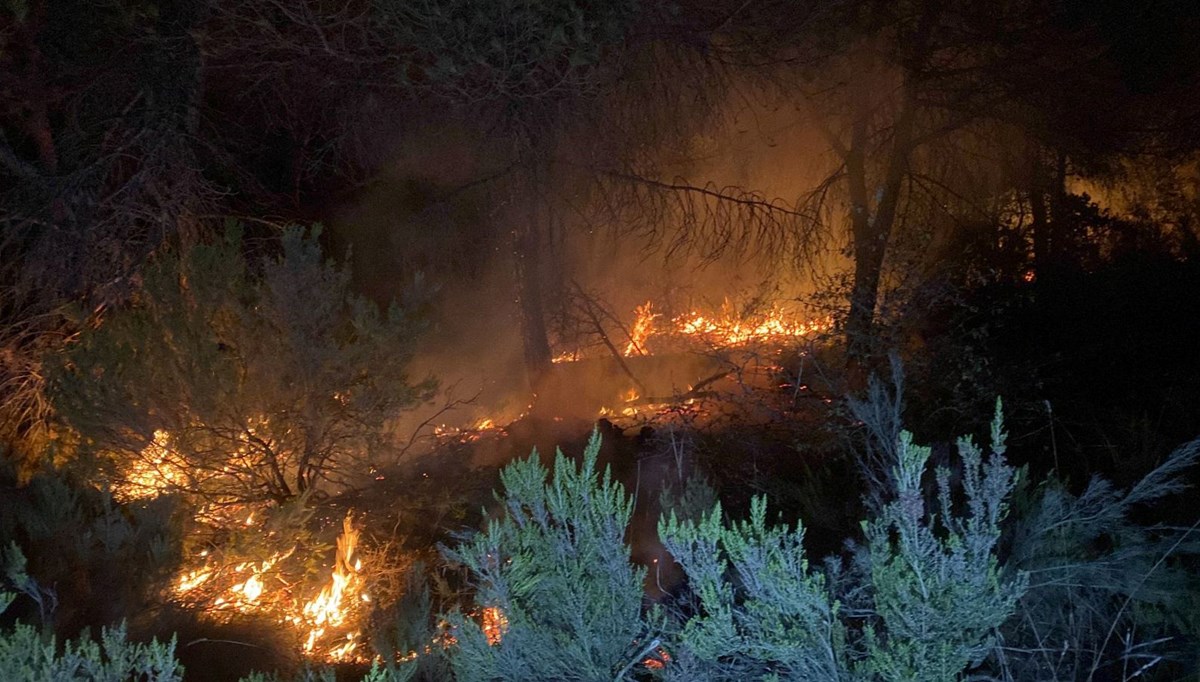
[52,226,432,502]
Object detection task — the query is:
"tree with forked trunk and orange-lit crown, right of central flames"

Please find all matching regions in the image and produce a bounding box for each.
[676,0,1194,367]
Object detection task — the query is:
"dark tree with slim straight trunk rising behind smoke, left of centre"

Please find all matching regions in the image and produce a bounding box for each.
[204,0,643,387]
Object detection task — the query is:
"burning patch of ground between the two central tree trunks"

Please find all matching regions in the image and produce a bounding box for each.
[538,299,833,423]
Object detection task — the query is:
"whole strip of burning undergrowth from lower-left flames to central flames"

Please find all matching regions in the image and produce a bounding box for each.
[79,292,829,663]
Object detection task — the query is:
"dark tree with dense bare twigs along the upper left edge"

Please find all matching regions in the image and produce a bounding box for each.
[0,0,215,459]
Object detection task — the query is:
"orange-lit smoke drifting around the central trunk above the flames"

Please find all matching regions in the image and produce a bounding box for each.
[330,78,854,437]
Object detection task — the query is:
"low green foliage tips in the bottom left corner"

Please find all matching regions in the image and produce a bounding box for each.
[0,593,184,682]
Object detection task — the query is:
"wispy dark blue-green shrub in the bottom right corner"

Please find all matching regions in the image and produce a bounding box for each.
[996,441,1200,680]
